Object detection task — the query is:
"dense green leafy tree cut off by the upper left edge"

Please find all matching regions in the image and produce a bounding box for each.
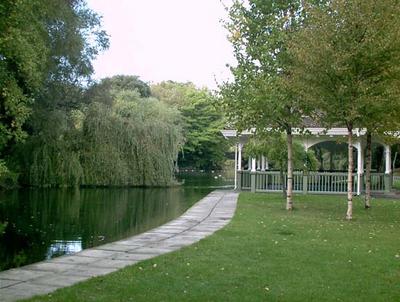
[0,0,49,153]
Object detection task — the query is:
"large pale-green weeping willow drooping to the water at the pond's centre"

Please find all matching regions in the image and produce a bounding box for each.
[81,91,182,186]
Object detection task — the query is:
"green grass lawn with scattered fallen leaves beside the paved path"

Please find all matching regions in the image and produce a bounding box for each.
[26,193,400,302]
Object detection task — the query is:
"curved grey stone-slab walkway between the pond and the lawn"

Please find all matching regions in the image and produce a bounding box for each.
[0,190,238,301]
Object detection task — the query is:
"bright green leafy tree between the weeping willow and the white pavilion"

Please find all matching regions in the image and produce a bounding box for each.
[151,81,228,169]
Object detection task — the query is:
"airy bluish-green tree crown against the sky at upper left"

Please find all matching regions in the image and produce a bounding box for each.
[42,0,109,83]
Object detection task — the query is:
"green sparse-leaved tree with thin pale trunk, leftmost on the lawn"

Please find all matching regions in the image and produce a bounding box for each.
[220,0,318,210]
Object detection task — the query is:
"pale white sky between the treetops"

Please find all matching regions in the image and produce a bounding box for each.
[88,0,235,89]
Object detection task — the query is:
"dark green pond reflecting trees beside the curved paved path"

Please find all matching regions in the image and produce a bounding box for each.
[0,173,232,271]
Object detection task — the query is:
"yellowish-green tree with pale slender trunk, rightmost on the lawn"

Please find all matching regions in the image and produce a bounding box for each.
[289,0,400,219]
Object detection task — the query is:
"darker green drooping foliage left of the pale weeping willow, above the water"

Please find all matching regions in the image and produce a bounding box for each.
[17,108,83,187]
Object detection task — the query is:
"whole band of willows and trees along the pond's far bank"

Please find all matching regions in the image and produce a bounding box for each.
[14,76,224,187]
